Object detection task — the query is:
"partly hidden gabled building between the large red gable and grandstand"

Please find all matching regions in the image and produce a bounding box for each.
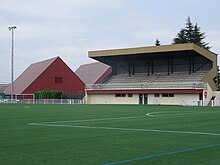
[75,62,111,84]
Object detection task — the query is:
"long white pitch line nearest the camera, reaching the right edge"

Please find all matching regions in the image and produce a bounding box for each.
[29,123,220,136]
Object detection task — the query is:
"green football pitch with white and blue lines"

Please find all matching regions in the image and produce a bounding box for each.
[0,104,220,165]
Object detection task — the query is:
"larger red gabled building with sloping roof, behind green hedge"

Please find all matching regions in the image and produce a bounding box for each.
[4,57,85,96]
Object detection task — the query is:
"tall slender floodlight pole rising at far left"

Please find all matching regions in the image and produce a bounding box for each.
[8,26,17,101]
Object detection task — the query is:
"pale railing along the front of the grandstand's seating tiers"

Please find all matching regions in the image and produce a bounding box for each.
[86,82,207,90]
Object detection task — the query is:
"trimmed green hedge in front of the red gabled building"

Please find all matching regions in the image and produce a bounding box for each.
[34,90,62,99]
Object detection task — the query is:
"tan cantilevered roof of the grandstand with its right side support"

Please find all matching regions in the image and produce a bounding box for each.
[88,43,217,90]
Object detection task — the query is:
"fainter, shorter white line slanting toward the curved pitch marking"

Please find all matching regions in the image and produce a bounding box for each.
[41,116,146,124]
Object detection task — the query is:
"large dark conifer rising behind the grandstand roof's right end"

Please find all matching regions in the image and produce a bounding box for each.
[173,17,210,50]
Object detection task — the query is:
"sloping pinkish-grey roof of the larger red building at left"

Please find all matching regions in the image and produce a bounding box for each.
[4,57,59,95]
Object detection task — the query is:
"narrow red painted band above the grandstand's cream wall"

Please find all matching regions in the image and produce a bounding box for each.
[86,89,203,94]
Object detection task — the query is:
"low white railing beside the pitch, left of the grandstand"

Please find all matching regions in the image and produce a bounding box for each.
[0,99,84,104]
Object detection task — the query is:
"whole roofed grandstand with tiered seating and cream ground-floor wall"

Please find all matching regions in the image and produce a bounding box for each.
[86,44,217,105]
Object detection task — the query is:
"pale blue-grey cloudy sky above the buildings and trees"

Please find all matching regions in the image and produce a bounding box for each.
[0,0,220,83]
